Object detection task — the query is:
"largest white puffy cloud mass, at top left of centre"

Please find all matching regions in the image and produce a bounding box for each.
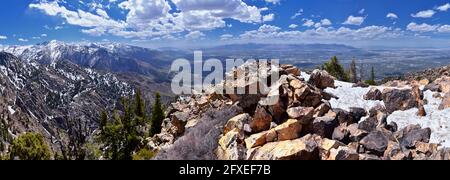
[29,0,268,39]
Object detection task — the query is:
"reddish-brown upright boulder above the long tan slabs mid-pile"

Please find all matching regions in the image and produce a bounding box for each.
[249,106,272,133]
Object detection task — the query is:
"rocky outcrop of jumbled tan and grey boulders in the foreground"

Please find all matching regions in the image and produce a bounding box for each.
[148,64,450,160]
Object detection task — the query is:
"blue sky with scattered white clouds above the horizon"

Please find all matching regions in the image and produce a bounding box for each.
[0,0,450,47]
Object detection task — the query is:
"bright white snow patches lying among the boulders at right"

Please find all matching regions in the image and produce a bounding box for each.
[302,73,450,147]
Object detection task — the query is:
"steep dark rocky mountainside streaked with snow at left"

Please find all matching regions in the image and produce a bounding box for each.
[0,53,133,155]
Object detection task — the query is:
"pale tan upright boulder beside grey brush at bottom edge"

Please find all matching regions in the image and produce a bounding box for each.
[216,128,246,160]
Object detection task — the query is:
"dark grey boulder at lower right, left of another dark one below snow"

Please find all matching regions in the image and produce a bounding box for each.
[360,131,389,156]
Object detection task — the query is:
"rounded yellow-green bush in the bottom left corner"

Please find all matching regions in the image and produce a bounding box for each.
[10,132,52,160]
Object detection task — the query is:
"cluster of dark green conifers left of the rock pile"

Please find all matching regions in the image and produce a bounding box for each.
[99,91,164,160]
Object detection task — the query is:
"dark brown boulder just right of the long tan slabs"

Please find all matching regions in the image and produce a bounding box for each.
[312,116,339,139]
